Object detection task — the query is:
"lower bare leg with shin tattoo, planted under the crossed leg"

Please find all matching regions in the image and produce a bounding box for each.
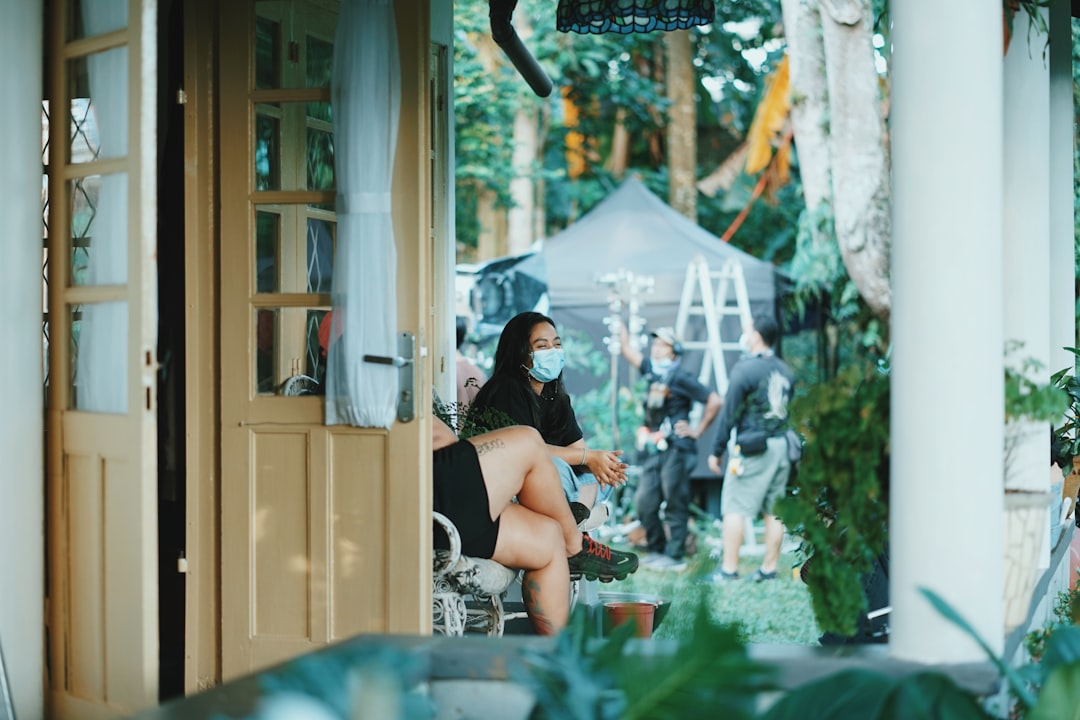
[491,504,570,635]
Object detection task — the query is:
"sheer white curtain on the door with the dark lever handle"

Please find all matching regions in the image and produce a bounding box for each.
[326,0,401,429]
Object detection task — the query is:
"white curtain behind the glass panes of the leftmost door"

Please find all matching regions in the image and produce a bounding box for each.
[72,0,129,412]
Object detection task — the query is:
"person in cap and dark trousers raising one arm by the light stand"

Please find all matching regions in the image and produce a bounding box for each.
[621,327,721,570]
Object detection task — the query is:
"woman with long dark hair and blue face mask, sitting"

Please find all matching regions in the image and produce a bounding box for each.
[473,312,627,529]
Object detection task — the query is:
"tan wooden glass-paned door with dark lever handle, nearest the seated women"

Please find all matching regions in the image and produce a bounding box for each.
[219,0,431,679]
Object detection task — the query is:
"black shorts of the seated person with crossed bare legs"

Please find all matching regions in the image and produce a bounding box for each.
[432,440,499,558]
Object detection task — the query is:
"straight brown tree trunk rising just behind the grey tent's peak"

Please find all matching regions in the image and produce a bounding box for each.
[664,30,698,222]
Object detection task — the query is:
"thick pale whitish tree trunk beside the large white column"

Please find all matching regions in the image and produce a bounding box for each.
[782,0,891,317]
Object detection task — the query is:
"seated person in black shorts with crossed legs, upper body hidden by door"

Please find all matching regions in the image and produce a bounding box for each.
[432,418,637,635]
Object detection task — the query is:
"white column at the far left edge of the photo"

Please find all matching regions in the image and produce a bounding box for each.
[0,0,44,718]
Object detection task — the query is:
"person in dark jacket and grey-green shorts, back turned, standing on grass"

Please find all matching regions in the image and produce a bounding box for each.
[708,315,795,582]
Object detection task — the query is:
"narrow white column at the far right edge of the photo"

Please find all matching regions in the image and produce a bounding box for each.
[1048,5,1077,372]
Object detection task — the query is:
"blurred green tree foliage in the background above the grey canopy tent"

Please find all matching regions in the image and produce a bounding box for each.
[455,0,800,263]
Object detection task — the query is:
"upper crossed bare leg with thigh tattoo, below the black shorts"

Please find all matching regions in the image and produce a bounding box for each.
[469,425,582,555]
